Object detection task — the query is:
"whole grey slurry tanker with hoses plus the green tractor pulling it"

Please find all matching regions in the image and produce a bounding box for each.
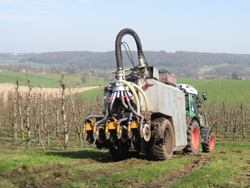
[83,29,215,160]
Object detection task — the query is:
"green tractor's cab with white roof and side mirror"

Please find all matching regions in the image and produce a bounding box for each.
[177,84,207,125]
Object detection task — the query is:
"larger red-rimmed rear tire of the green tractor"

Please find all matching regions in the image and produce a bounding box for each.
[183,120,201,155]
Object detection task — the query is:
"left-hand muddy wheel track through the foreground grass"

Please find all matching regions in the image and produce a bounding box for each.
[4,157,157,187]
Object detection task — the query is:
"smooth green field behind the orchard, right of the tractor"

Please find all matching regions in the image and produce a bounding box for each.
[177,78,250,104]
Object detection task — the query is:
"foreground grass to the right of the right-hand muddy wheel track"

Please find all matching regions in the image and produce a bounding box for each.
[172,142,250,187]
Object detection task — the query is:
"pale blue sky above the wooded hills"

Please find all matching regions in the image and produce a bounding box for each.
[0,0,250,54]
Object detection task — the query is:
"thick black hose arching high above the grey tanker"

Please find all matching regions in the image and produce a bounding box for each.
[115,28,144,70]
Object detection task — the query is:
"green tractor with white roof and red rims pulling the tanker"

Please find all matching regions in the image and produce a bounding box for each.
[177,84,215,154]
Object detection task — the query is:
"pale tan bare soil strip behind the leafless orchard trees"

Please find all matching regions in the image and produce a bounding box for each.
[0,84,99,98]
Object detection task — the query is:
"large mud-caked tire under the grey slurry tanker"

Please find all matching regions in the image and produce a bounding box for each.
[145,117,174,161]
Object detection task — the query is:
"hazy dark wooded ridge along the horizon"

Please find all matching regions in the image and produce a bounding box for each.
[20,51,250,76]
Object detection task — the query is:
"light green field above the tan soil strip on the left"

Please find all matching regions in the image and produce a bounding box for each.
[0,72,107,88]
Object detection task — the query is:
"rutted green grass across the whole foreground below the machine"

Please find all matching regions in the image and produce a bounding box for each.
[0,142,250,188]
